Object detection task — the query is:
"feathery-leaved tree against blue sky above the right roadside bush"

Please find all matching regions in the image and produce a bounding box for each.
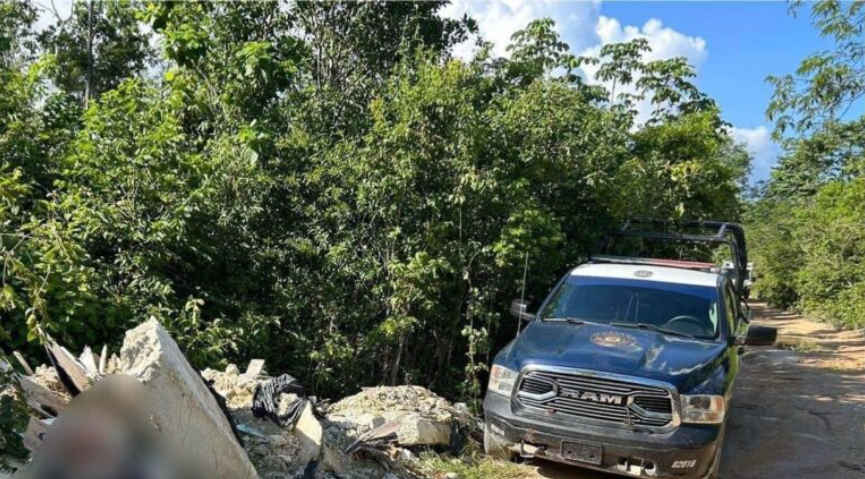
[766,0,865,195]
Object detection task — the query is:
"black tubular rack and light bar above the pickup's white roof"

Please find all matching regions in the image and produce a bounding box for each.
[589,218,748,295]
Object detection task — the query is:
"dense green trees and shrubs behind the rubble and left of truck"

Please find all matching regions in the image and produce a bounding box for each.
[0,2,748,404]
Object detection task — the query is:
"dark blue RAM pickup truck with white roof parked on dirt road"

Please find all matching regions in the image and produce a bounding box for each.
[484,221,776,479]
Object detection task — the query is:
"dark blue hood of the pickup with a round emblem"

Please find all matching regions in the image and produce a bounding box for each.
[496,321,727,392]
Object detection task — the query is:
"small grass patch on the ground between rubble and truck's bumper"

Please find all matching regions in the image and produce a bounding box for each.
[420,452,529,479]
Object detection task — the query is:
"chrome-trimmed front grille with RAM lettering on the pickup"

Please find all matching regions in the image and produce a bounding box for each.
[517,370,674,428]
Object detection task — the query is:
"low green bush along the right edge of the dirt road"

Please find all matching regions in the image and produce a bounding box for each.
[748,178,865,328]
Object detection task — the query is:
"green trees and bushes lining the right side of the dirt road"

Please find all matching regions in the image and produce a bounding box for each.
[748,0,865,328]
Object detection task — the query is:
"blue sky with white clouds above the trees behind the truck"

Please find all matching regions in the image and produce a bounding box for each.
[438,0,830,181]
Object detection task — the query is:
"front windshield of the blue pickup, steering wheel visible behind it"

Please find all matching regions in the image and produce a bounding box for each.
[541,276,720,339]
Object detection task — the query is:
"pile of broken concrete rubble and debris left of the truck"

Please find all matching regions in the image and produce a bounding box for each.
[3,319,470,479]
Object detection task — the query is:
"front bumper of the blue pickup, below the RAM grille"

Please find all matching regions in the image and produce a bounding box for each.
[484,393,723,479]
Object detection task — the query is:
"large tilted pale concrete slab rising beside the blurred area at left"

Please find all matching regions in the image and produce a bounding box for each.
[119,318,258,479]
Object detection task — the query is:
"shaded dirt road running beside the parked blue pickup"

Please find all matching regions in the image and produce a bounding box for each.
[527,303,865,479]
